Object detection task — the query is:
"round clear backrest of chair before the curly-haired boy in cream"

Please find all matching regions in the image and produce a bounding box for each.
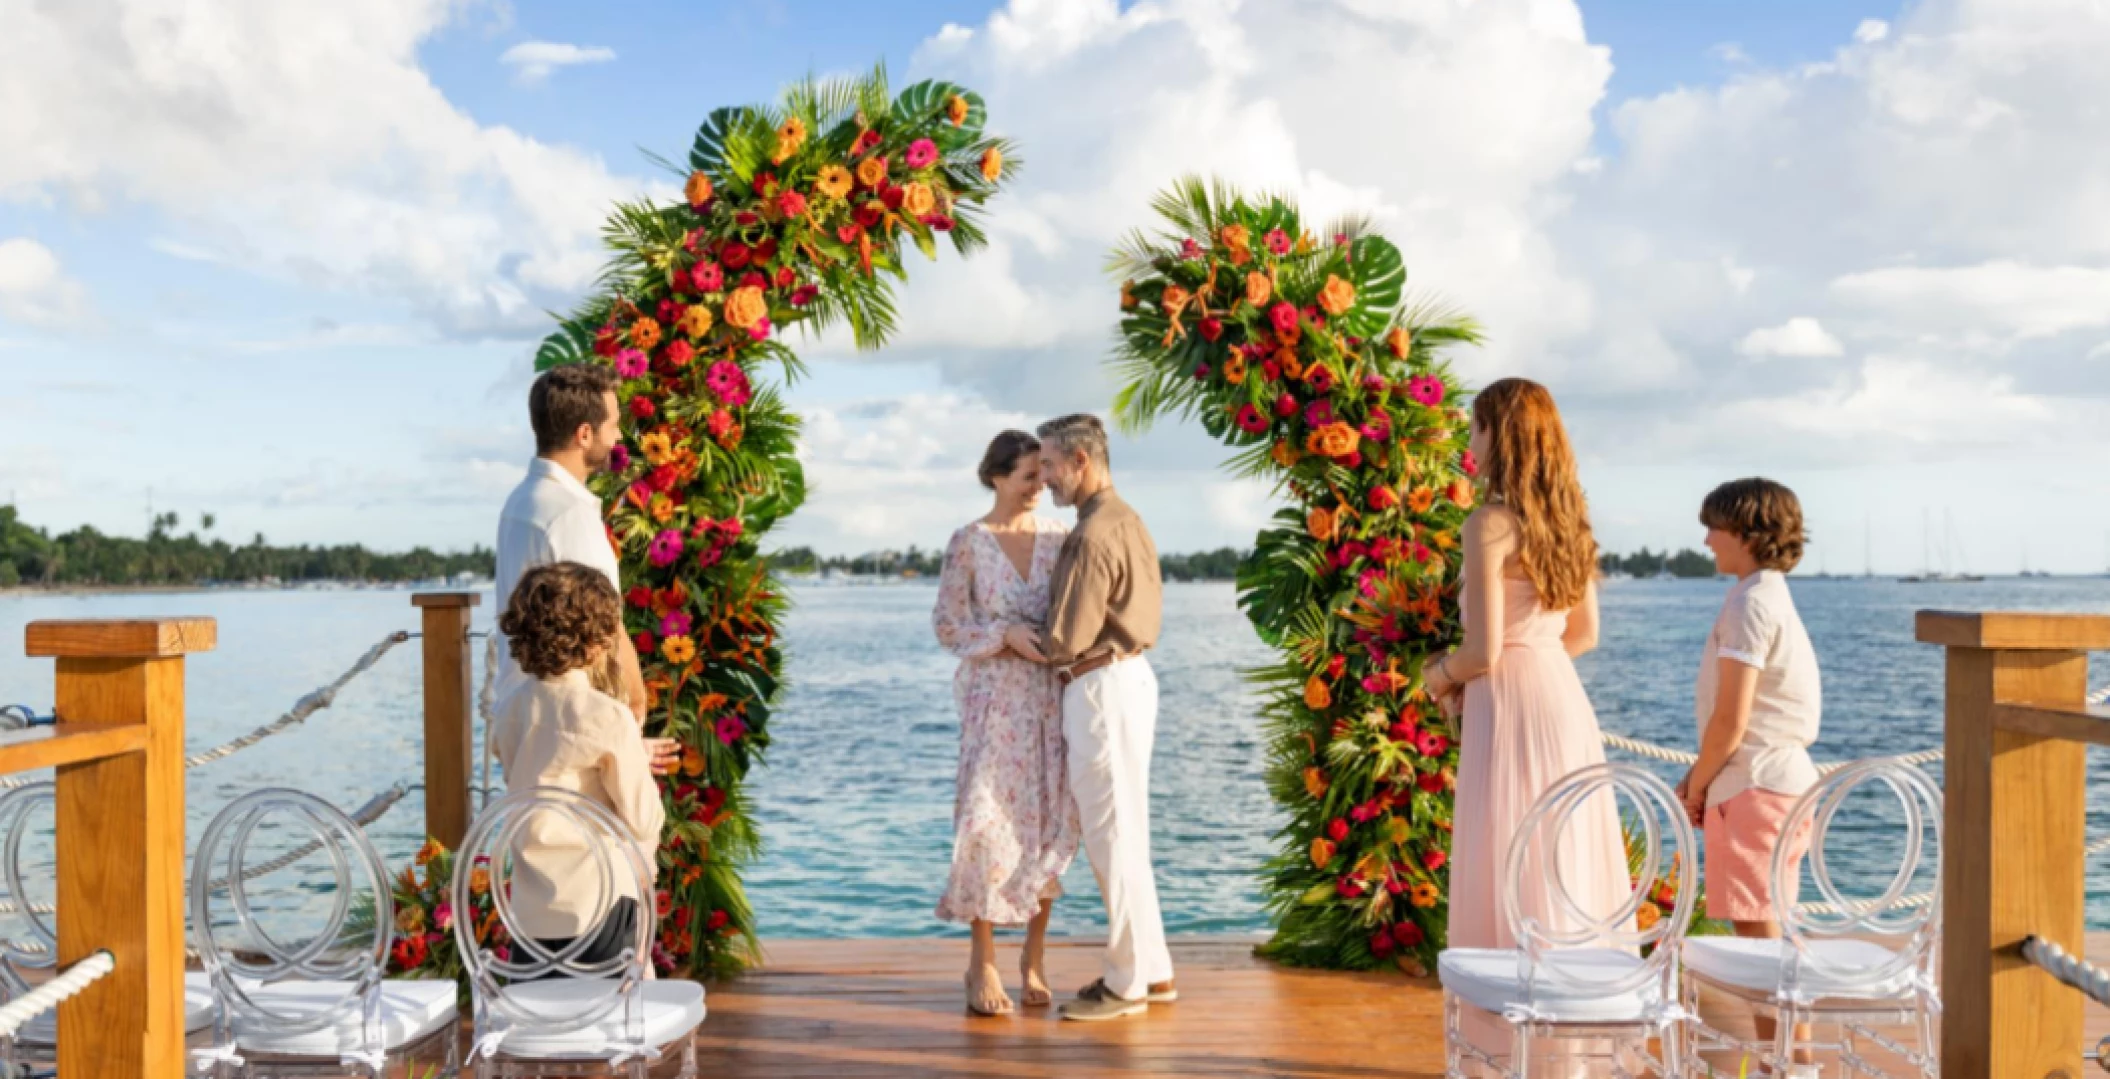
[452,788,654,1043]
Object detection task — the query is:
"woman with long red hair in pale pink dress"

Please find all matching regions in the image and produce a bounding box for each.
[1424,378,1633,1054]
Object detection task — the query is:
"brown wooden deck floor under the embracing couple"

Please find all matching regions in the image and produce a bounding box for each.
[346,935,2110,1079]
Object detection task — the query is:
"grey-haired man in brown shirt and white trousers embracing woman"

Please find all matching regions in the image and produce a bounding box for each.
[1015,416,1177,1022]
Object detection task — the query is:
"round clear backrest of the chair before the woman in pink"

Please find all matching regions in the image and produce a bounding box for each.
[1502,764,1694,999]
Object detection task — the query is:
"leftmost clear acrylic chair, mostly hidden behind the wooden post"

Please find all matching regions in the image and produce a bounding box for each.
[0,779,219,1075]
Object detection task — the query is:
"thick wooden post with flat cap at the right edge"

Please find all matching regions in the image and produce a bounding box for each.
[1916,610,2110,1079]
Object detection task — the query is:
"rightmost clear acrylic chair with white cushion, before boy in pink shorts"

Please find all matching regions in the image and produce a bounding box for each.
[1684,760,1941,1077]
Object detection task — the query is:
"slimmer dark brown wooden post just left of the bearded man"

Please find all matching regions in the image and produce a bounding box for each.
[409,591,481,851]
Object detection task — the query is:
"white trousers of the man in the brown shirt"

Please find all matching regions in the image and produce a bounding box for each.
[1061,657,1173,1001]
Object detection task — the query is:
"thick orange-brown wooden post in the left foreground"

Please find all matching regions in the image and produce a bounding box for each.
[25,619,217,1079]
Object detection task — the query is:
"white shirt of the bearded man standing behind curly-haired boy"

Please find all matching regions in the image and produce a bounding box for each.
[492,456,622,701]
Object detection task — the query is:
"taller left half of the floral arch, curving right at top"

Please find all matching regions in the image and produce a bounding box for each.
[536,72,1019,973]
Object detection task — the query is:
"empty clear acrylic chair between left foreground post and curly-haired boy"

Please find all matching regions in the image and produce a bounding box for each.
[190,788,460,1079]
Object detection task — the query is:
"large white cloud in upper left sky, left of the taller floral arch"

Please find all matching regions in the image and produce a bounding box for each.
[0,0,644,336]
